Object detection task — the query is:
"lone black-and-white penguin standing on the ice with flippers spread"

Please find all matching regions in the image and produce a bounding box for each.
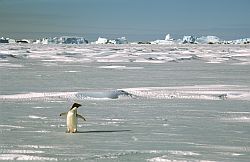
[60,103,86,133]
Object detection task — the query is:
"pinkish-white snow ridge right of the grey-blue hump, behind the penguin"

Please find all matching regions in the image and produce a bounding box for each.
[123,85,250,100]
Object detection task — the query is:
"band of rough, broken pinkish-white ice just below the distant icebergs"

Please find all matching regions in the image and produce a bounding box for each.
[0,44,250,65]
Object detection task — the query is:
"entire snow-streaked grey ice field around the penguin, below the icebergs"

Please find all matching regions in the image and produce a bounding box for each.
[0,44,250,162]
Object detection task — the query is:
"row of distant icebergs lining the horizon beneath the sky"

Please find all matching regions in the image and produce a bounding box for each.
[0,34,250,45]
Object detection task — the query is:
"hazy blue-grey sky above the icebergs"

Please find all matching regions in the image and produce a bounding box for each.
[0,0,250,40]
